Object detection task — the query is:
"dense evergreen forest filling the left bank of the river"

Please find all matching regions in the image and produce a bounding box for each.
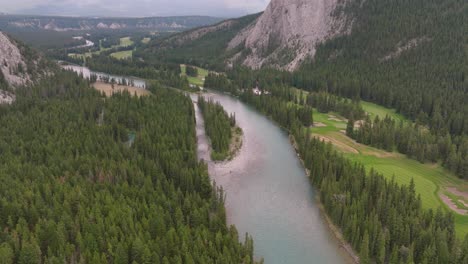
[0,72,253,264]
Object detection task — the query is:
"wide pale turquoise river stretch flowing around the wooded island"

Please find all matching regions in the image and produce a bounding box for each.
[192,92,351,264]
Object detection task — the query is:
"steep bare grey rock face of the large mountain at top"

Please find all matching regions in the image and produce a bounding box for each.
[228,0,352,70]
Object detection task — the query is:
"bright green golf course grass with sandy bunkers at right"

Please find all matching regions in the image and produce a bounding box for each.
[292,88,468,238]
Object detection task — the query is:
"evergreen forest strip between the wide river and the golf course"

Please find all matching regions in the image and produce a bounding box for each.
[212,87,468,264]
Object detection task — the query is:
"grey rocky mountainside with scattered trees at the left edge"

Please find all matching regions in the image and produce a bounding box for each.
[0,31,52,104]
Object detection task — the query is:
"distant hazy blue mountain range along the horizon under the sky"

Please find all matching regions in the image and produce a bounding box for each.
[0,15,222,31]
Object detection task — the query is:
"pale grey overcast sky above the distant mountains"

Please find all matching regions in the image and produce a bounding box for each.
[0,0,270,17]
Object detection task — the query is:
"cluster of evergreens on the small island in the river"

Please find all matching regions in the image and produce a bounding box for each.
[198,96,239,161]
